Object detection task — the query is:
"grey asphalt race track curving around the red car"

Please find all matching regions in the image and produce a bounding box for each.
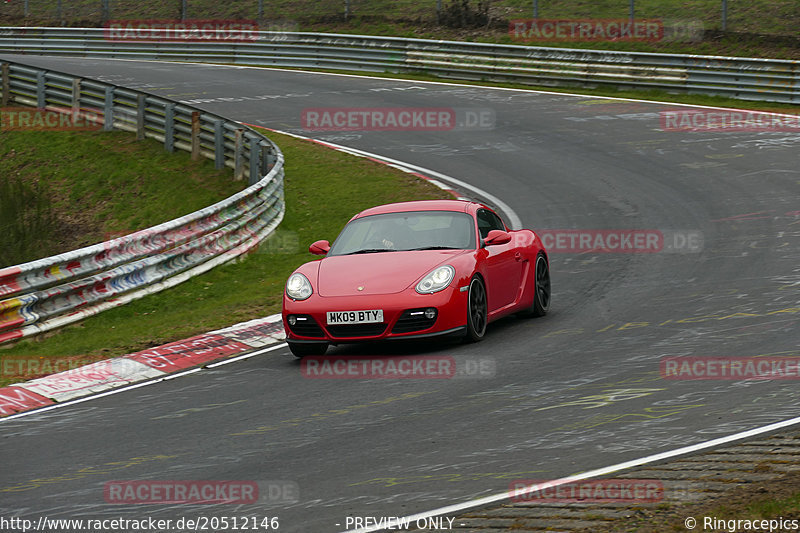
[0,56,800,533]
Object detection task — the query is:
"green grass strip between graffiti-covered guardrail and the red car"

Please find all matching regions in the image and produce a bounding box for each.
[0,125,450,385]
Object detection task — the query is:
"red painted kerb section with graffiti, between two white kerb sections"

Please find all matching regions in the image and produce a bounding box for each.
[125,334,251,373]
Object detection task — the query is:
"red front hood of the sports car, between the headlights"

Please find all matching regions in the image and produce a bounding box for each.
[317,250,468,297]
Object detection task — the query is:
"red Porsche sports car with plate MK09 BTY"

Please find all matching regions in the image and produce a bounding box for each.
[283,200,550,357]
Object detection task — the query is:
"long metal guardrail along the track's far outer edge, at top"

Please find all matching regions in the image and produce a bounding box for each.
[0,27,800,103]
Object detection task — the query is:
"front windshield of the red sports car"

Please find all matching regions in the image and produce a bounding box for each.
[328,211,475,256]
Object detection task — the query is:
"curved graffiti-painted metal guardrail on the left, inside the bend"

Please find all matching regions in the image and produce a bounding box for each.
[0,58,285,343]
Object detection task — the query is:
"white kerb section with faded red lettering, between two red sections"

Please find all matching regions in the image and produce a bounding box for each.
[19,357,163,402]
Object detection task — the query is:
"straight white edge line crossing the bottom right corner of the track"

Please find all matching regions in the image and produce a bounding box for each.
[345,417,800,533]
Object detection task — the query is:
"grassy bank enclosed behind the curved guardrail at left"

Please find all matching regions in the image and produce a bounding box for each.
[0,125,244,267]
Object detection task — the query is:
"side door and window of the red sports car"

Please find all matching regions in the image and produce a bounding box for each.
[476,209,525,313]
